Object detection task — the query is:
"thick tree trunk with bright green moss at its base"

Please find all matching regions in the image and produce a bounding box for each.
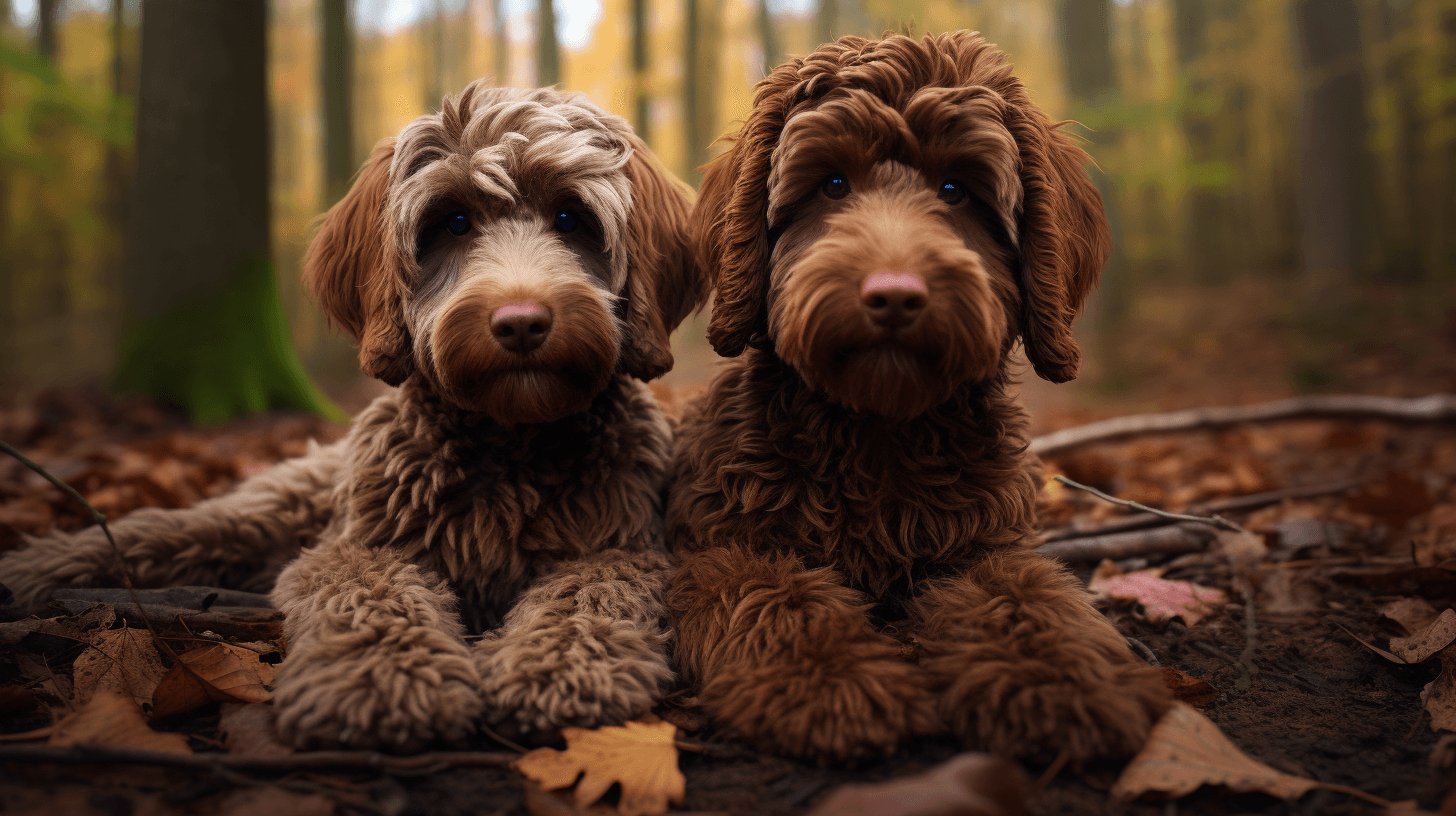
[115,0,342,424]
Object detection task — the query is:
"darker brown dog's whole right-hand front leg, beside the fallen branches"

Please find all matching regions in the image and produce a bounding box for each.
[911,549,1172,761]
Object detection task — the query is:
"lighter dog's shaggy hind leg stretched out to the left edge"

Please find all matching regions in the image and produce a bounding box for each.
[0,443,342,608]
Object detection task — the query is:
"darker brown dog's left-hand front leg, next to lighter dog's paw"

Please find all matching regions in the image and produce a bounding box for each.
[668,548,939,759]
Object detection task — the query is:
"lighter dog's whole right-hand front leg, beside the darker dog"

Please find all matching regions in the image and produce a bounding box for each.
[475,549,673,733]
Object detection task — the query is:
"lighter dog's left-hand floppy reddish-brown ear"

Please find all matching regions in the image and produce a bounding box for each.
[303,140,414,385]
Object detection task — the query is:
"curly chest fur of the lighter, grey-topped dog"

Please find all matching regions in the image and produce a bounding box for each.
[335,377,671,629]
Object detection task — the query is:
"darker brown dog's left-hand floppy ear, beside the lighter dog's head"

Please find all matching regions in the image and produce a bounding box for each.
[693,62,809,357]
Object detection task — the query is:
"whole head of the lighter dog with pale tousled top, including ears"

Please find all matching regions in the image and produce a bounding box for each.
[306,82,706,425]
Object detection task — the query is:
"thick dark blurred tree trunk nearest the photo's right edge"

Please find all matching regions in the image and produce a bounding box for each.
[1294,0,1366,300]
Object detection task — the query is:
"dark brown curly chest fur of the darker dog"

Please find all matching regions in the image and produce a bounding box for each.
[667,350,1037,599]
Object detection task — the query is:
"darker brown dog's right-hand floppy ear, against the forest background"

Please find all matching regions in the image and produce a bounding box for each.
[1006,107,1112,382]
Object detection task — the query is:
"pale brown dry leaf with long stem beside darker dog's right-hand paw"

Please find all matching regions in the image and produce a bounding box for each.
[1112,702,1390,807]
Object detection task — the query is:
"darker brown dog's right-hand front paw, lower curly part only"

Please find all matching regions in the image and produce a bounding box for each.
[925,643,1172,764]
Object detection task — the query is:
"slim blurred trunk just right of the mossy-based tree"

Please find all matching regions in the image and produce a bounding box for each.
[323,0,355,205]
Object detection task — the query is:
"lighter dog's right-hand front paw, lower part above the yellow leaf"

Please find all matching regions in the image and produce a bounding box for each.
[475,615,673,734]
